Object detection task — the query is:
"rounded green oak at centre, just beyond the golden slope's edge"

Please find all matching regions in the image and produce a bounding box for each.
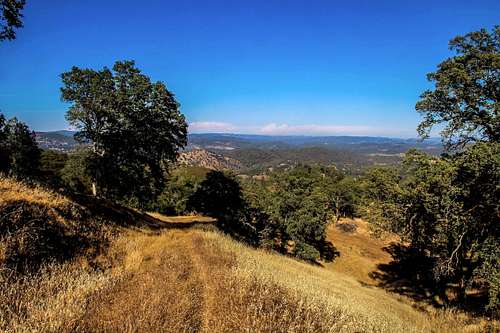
[244,165,342,261]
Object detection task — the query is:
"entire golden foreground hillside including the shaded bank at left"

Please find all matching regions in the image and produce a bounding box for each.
[0,178,492,332]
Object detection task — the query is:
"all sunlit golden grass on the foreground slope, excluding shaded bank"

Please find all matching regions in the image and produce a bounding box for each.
[0,179,494,332]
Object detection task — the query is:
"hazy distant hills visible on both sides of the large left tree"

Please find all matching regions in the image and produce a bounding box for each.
[36,130,442,173]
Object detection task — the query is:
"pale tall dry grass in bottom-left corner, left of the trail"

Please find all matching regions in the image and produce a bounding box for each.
[0,263,114,332]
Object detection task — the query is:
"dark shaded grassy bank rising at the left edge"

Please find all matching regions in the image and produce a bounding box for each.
[0,177,118,271]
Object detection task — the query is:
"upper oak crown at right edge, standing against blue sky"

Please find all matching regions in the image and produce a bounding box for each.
[416,26,500,148]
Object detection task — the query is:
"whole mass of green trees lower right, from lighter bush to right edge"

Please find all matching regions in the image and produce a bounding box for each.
[365,143,500,309]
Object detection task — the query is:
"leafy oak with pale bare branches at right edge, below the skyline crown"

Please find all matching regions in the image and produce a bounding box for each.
[399,147,500,303]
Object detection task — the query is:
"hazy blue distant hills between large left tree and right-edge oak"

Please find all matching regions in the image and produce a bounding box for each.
[188,134,442,174]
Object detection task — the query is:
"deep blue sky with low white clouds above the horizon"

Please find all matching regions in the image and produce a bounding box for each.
[0,0,500,137]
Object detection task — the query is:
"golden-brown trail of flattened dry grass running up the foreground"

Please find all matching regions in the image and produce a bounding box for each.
[75,230,208,332]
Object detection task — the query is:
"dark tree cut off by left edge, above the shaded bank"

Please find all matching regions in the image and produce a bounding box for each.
[0,114,40,178]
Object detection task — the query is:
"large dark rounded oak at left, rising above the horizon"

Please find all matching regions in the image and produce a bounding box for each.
[61,61,187,205]
